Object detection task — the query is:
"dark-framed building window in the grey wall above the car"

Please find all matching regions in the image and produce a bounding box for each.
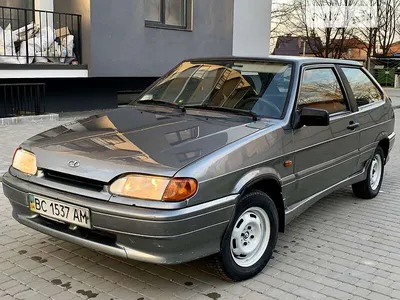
[144,0,193,30]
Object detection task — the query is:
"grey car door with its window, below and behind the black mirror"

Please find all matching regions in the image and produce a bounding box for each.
[289,65,359,205]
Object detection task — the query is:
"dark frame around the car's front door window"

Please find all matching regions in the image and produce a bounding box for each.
[294,64,354,119]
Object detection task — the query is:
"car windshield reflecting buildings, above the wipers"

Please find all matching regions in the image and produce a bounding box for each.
[136,61,292,118]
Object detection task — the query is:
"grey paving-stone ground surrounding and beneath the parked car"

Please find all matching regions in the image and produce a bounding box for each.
[0,105,400,300]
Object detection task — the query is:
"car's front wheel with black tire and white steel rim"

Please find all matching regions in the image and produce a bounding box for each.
[209,191,279,281]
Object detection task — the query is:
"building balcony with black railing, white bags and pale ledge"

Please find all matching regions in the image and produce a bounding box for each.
[0,6,88,78]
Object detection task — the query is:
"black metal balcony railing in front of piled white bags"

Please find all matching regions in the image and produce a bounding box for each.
[0,6,82,64]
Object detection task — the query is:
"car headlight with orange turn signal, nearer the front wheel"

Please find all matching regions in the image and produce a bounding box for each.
[110,175,197,202]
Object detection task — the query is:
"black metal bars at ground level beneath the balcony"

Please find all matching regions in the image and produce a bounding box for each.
[0,83,46,118]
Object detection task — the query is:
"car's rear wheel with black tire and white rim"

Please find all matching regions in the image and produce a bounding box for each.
[352,146,385,199]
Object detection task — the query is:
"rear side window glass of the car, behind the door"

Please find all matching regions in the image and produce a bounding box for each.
[342,68,383,106]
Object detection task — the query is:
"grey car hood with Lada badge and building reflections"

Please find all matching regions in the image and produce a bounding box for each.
[22,107,268,182]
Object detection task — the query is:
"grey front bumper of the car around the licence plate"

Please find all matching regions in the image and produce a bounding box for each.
[3,173,237,264]
